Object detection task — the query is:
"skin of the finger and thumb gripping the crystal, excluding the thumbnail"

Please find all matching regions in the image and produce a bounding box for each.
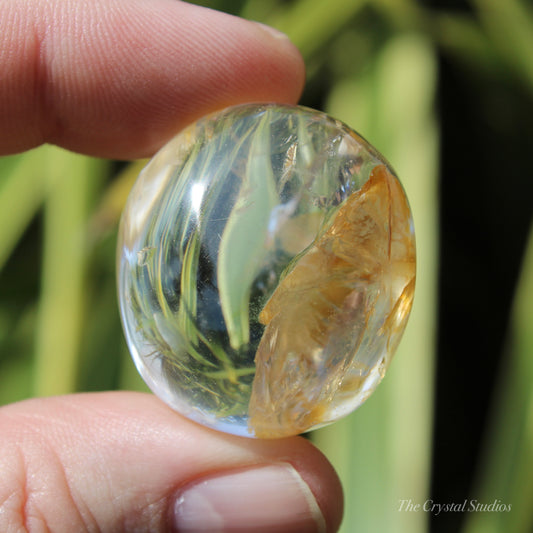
[0,0,342,532]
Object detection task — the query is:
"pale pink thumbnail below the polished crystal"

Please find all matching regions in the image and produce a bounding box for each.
[174,464,326,533]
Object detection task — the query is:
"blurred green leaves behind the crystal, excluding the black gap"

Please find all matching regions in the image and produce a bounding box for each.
[0,0,533,533]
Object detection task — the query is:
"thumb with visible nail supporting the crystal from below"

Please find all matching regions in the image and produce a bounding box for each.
[0,392,342,533]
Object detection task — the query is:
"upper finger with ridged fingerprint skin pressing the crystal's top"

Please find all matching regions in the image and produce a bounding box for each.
[0,0,304,158]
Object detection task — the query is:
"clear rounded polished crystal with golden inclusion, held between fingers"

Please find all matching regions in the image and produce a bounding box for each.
[118,104,415,438]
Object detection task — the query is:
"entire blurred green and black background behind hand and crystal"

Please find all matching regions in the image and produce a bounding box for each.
[0,0,533,533]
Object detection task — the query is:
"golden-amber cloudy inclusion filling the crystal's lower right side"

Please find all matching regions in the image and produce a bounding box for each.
[249,165,415,438]
